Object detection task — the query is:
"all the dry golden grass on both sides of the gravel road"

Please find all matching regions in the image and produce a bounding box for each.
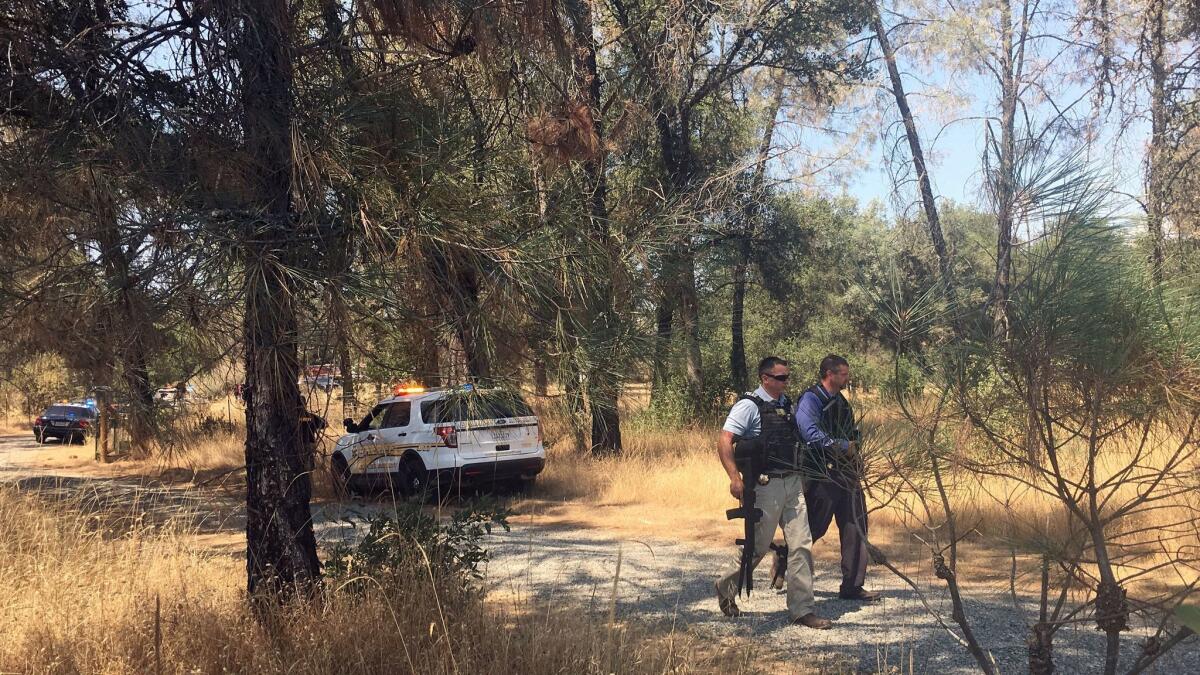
[0,386,1200,673]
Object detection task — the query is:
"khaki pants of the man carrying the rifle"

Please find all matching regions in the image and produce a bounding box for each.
[716,474,816,620]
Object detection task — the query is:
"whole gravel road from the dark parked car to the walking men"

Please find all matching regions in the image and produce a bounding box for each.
[0,436,1200,673]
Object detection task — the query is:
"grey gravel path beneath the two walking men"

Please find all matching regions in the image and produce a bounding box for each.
[320,507,1200,674]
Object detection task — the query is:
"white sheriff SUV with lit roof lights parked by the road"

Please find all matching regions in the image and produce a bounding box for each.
[330,384,546,500]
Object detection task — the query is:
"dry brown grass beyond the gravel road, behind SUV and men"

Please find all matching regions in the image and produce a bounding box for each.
[16,393,1200,593]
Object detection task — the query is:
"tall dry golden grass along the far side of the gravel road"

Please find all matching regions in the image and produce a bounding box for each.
[18,392,1200,590]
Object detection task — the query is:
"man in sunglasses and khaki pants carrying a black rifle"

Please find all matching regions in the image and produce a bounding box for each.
[716,357,832,629]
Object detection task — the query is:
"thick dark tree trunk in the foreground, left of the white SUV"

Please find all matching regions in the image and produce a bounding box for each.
[236,0,320,601]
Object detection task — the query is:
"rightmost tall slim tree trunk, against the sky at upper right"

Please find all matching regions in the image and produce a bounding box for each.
[1146,0,1166,283]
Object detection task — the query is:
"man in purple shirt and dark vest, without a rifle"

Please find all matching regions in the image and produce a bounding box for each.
[796,354,880,602]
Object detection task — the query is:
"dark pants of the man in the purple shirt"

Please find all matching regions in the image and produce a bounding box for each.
[804,477,866,593]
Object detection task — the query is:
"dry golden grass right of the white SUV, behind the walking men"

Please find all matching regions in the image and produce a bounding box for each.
[529,396,1200,591]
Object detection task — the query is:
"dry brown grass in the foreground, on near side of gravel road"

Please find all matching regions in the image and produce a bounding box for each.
[0,488,750,674]
